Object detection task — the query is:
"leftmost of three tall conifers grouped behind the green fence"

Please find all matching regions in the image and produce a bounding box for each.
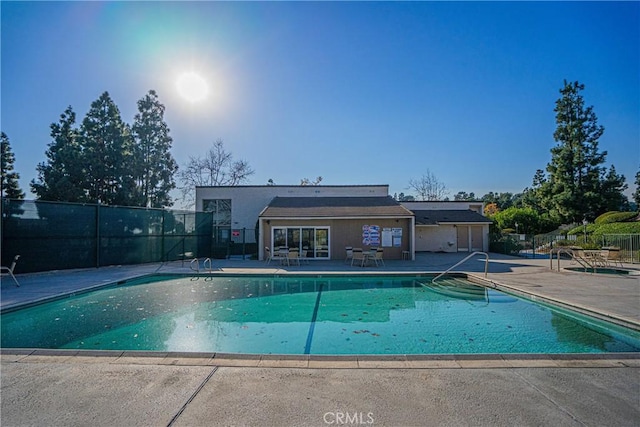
[31,106,88,202]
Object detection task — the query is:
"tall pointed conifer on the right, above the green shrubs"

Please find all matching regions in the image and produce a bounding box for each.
[533,81,624,223]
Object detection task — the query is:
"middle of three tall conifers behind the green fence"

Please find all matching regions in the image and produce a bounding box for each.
[79,92,137,206]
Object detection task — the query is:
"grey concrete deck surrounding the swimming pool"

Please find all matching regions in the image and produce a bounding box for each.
[0,254,640,426]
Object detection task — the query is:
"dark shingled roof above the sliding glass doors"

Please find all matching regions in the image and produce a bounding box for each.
[260,196,413,218]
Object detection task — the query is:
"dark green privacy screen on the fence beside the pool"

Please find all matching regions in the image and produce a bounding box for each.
[2,199,218,273]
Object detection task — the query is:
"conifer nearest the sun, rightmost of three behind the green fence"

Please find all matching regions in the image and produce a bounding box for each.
[131,90,178,208]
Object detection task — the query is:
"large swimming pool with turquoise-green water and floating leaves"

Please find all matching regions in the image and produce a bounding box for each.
[1,275,640,355]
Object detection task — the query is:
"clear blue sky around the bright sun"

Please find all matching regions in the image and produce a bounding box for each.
[0,1,640,206]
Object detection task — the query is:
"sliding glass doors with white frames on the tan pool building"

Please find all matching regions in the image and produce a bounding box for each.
[271,227,330,259]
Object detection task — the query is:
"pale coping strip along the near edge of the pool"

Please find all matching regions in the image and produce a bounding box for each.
[0,349,640,369]
